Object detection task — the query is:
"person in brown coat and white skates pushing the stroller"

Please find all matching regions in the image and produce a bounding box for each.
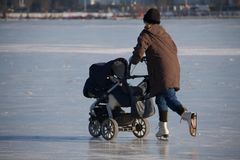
[129,8,197,140]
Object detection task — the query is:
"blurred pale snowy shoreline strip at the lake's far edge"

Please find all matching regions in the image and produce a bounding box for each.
[0,12,240,20]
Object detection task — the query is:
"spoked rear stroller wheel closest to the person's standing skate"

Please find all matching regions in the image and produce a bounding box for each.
[132,118,150,138]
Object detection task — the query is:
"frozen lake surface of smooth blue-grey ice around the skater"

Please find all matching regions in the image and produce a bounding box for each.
[0,19,240,160]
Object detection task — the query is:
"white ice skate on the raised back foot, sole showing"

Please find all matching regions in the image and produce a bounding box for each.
[181,111,197,137]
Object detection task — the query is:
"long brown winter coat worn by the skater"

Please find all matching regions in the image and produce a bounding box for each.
[131,24,180,96]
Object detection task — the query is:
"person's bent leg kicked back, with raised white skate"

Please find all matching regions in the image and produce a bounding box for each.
[163,89,197,136]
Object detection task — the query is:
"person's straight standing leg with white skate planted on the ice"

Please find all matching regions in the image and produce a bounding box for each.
[155,94,169,140]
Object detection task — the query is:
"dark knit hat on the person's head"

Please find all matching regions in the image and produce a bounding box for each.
[143,8,160,24]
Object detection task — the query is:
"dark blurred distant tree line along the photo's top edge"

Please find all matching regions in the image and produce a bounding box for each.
[0,0,240,13]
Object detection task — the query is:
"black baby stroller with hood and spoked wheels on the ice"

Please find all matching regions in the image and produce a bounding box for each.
[83,58,155,140]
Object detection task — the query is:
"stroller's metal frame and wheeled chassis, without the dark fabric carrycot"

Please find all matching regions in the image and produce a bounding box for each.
[88,57,150,140]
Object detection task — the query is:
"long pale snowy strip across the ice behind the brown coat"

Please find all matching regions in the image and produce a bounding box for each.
[0,44,240,55]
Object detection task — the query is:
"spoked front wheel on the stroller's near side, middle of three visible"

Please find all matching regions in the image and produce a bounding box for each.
[101,118,118,140]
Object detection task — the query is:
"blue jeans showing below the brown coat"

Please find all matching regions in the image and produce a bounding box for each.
[155,88,185,115]
